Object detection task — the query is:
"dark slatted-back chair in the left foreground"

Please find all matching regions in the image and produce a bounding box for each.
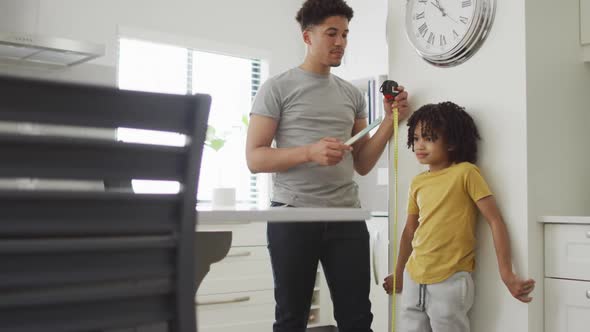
[0,78,211,332]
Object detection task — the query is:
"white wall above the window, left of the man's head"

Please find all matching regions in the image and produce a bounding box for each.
[0,0,304,85]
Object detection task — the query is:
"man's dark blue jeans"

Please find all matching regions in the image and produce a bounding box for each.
[267,202,373,332]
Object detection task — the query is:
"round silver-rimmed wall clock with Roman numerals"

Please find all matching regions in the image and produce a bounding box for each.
[406,0,496,67]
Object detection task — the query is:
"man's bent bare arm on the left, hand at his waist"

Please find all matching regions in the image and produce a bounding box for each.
[246,114,351,173]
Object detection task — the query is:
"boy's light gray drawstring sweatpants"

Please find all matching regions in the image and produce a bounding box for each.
[400,271,474,332]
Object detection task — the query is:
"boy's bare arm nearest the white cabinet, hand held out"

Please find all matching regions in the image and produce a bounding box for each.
[476,195,535,303]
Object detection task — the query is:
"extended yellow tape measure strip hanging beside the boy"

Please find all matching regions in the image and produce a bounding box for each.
[391,108,399,332]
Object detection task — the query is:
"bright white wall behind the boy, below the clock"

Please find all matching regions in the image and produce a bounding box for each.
[389,0,539,332]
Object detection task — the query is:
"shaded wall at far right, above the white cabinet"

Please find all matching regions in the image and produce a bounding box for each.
[526,0,590,331]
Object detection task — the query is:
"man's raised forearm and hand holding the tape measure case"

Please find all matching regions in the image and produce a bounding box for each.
[352,86,410,175]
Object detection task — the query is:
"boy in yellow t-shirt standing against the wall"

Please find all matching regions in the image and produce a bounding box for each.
[383,102,535,332]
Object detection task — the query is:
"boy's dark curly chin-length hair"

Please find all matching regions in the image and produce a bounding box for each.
[407,101,480,163]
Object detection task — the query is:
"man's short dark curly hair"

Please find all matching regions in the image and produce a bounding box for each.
[295,0,353,31]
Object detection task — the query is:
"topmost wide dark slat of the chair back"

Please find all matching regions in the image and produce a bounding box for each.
[0,77,196,135]
